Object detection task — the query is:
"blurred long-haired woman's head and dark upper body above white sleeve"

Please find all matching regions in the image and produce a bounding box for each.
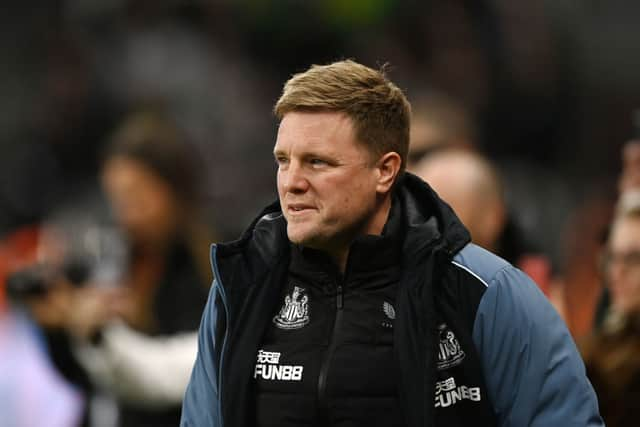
[102,108,212,333]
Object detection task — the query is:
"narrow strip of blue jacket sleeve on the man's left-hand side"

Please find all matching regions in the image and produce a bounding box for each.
[180,280,222,427]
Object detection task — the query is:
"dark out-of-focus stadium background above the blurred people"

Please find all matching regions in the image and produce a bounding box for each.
[0,0,640,336]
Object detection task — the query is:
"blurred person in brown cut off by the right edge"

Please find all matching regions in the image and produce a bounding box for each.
[581,199,640,427]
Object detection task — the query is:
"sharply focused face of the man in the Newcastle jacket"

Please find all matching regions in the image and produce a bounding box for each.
[274,112,384,253]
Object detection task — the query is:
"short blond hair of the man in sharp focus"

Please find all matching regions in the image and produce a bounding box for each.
[273,60,411,172]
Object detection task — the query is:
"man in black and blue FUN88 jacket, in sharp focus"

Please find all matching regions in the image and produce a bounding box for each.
[182,61,602,427]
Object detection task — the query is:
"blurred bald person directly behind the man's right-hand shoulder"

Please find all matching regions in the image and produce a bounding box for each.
[414,147,551,296]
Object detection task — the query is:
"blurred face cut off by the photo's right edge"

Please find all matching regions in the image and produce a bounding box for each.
[606,218,640,313]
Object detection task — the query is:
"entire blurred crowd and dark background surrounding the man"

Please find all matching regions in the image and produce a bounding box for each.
[0,0,640,427]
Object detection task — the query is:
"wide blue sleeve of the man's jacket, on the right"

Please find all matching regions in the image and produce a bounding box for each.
[473,266,604,427]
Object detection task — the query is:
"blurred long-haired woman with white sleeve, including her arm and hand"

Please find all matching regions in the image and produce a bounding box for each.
[69,112,212,427]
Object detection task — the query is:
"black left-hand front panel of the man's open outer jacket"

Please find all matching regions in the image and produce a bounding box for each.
[219,209,289,427]
